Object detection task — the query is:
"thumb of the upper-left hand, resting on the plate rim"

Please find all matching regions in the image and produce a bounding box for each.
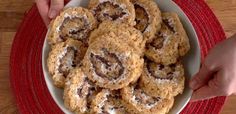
[48,0,64,19]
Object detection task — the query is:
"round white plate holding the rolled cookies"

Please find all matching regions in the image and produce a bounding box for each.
[42,0,200,114]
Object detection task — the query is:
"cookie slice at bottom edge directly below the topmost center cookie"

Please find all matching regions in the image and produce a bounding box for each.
[92,89,128,114]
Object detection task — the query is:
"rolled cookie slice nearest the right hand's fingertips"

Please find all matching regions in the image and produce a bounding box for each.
[139,60,185,98]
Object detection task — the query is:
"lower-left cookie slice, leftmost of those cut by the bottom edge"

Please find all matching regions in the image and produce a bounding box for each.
[63,68,101,114]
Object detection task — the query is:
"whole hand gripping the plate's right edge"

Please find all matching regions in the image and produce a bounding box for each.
[189,34,236,101]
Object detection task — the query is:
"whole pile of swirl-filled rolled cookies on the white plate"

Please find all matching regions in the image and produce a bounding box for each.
[47,0,190,114]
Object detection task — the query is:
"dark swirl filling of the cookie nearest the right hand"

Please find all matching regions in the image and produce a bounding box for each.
[146,60,176,80]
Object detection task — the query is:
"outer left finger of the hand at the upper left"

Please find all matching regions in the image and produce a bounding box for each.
[35,0,50,26]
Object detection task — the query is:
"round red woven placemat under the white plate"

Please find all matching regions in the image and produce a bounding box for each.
[10,0,225,114]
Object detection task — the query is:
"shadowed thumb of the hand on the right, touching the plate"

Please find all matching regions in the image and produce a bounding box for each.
[189,64,214,90]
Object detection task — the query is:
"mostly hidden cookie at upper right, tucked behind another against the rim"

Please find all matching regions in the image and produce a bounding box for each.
[162,12,190,56]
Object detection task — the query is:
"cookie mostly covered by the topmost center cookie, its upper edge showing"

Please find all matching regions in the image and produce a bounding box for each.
[89,21,146,55]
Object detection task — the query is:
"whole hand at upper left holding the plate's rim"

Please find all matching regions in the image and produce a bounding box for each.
[35,0,64,26]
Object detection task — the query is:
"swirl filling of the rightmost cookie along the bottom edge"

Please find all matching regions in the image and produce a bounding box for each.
[133,85,160,108]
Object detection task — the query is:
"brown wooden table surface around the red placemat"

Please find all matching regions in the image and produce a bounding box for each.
[0,0,236,114]
